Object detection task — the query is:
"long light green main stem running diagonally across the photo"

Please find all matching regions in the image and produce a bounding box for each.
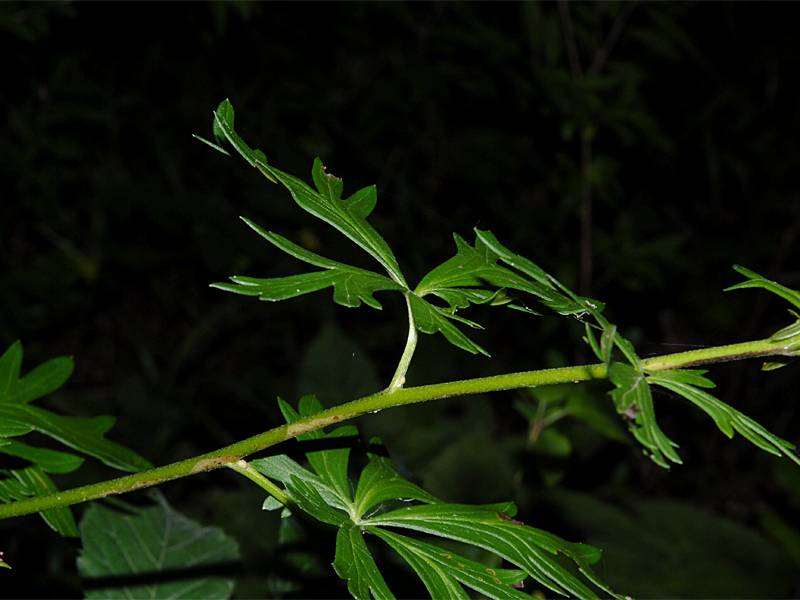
[0,332,792,519]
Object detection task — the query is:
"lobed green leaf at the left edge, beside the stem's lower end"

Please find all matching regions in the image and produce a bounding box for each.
[0,342,150,536]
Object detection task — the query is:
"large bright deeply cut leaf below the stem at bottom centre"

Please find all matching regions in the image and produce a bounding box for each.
[251,396,612,600]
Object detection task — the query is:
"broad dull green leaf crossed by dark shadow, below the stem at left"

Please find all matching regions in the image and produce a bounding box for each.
[78,494,239,600]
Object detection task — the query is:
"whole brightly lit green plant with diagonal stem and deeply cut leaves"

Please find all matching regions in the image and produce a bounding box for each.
[0,100,800,600]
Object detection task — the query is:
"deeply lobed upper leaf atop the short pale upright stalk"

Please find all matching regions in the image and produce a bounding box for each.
[200,100,585,356]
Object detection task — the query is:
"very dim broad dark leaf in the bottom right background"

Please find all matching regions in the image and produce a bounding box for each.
[543,490,797,598]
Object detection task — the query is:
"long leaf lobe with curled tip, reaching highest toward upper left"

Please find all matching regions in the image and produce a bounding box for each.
[214,99,405,286]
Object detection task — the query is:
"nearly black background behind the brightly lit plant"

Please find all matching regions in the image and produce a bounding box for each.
[0,2,800,597]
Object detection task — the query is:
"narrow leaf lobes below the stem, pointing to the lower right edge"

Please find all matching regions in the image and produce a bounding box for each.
[647,369,800,465]
